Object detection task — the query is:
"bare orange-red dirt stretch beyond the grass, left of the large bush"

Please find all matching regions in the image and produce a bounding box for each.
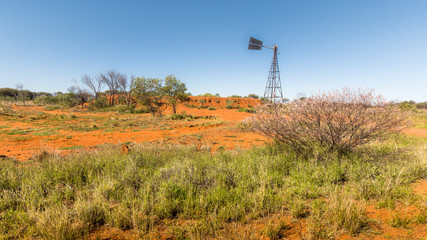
[0,97,268,161]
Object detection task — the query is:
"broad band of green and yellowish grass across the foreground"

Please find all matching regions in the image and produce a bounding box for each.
[0,137,427,239]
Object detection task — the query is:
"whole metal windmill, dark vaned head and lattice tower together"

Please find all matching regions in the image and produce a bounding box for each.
[248,37,283,103]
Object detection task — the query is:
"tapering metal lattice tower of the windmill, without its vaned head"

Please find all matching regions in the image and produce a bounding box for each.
[264,45,283,103]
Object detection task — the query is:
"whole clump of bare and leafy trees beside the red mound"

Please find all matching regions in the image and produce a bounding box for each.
[68,70,189,116]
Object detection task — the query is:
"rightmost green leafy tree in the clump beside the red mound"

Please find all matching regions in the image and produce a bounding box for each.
[163,75,188,113]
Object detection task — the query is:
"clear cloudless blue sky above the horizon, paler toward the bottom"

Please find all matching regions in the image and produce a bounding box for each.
[0,0,427,102]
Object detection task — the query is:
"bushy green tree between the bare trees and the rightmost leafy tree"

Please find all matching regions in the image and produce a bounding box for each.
[131,77,167,116]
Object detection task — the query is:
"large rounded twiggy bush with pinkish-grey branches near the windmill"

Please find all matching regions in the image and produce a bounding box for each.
[248,88,408,153]
